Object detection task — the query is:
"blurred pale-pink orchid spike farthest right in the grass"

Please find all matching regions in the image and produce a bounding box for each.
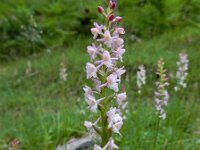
[174,53,189,91]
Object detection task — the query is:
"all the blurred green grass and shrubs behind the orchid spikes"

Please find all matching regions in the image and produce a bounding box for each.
[0,0,200,150]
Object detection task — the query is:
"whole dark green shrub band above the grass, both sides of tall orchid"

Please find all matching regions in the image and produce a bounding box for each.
[0,0,200,61]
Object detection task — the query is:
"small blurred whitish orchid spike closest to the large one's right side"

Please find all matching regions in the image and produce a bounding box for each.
[137,65,146,94]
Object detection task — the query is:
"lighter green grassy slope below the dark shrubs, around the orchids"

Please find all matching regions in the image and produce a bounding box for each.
[0,26,200,150]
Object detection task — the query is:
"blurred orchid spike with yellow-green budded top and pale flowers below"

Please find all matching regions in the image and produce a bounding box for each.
[155,59,169,119]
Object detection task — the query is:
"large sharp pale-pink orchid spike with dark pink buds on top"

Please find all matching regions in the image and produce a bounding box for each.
[84,0,127,150]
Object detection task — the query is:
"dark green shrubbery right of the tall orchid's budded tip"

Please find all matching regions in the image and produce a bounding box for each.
[119,0,200,38]
